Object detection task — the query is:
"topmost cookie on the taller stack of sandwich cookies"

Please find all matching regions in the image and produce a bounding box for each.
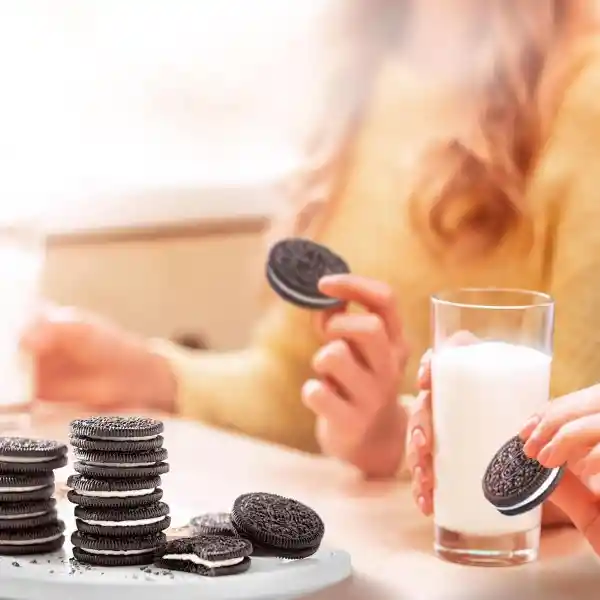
[71,417,164,443]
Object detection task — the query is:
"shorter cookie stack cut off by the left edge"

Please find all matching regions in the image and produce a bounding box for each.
[0,437,67,556]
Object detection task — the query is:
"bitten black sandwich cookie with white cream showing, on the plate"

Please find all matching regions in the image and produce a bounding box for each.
[154,535,252,577]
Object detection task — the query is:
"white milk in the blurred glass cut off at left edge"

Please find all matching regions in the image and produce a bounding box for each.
[0,244,43,410]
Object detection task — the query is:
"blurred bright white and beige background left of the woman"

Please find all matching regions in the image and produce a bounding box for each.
[0,0,339,349]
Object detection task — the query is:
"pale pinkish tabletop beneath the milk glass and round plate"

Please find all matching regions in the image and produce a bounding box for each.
[25,408,600,600]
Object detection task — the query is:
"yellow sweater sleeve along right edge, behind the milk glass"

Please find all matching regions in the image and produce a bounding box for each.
[547,51,600,396]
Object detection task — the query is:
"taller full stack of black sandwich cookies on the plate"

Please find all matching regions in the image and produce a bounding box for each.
[67,417,171,567]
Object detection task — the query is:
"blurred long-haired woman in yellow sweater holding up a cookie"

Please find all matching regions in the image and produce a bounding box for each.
[24,0,600,475]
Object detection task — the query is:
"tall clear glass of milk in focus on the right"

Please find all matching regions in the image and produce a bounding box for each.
[431,288,554,565]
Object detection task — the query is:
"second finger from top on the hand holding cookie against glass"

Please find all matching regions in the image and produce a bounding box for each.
[537,413,600,468]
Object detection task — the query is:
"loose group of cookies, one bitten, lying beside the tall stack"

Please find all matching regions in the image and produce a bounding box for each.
[155,493,325,577]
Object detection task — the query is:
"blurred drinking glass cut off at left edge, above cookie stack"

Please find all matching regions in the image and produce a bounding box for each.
[0,221,45,435]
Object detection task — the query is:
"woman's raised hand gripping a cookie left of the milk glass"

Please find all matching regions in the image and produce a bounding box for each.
[302,274,408,477]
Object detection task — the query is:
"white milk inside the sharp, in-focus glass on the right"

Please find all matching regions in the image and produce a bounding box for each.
[432,342,551,535]
